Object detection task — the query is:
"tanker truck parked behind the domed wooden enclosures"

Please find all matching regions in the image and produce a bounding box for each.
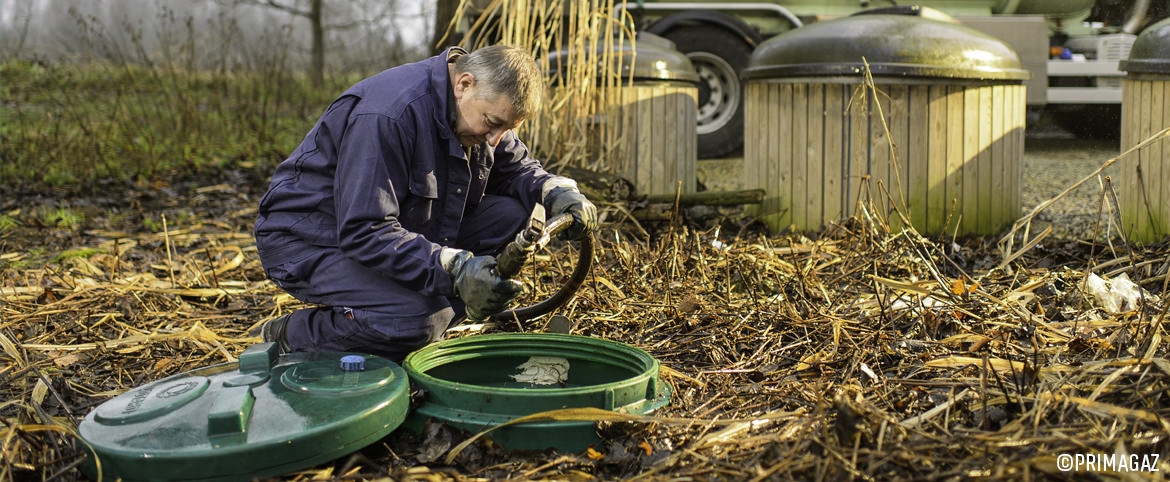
[614,0,1170,158]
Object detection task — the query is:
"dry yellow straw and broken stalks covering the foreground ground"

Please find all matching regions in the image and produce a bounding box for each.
[0,167,1170,482]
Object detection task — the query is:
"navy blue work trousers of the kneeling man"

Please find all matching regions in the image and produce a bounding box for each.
[256,195,529,362]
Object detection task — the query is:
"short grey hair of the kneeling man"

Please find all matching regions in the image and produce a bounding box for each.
[455,44,544,119]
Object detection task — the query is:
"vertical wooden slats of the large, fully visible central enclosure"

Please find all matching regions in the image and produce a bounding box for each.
[744,80,1026,234]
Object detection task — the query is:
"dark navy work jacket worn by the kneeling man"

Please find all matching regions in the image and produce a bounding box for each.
[255,49,552,296]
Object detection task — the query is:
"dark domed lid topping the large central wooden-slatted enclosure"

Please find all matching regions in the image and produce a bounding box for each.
[742,6,1031,82]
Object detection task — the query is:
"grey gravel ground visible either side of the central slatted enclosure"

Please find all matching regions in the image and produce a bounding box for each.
[697,121,1121,240]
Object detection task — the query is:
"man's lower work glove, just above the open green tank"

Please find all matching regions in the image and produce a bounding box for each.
[448,252,524,322]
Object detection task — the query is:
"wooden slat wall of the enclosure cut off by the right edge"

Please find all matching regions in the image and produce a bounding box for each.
[1117,78,1170,243]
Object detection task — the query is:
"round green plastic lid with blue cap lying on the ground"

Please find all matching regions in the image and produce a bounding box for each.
[77,343,410,482]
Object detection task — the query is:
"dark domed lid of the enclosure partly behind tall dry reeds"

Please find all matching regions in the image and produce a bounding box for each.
[548,32,698,82]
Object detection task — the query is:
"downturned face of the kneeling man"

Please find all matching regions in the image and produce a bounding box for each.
[453,73,523,147]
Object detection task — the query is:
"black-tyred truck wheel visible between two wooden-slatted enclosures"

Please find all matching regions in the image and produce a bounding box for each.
[662,26,751,158]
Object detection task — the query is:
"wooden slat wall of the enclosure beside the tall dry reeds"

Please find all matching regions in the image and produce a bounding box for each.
[593,81,698,195]
